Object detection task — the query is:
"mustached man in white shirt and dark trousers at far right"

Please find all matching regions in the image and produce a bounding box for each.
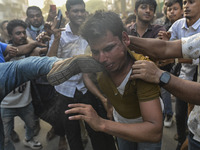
[166,0,200,150]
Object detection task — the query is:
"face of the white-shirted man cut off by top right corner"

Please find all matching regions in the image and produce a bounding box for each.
[183,0,200,20]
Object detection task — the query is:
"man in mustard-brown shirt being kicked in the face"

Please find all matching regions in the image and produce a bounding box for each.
[66,11,162,150]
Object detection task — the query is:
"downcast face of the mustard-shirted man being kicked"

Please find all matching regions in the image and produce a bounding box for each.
[89,31,129,73]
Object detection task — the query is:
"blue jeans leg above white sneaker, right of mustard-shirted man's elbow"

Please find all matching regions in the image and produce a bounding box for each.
[161,88,173,116]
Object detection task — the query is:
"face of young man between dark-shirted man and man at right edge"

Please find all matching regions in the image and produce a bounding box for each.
[167,3,183,23]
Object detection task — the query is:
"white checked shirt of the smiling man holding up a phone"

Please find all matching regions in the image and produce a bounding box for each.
[49,23,88,98]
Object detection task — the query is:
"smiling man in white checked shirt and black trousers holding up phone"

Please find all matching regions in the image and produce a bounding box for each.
[47,0,115,150]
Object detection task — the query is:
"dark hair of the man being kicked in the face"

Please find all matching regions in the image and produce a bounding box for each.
[81,10,126,42]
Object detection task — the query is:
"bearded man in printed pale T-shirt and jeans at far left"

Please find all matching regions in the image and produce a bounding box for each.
[1,20,42,150]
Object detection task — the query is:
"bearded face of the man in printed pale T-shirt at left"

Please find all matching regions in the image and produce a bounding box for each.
[11,26,27,46]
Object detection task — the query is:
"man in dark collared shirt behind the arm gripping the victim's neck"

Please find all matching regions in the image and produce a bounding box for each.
[128,0,165,38]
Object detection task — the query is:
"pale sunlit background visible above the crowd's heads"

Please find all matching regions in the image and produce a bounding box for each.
[0,0,163,22]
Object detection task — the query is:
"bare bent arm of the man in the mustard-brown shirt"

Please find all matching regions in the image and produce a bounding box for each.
[65,97,162,142]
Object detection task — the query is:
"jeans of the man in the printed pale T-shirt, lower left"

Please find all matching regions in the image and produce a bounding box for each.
[1,103,35,150]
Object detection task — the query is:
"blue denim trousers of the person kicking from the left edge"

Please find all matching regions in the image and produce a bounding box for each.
[0,57,58,150]
